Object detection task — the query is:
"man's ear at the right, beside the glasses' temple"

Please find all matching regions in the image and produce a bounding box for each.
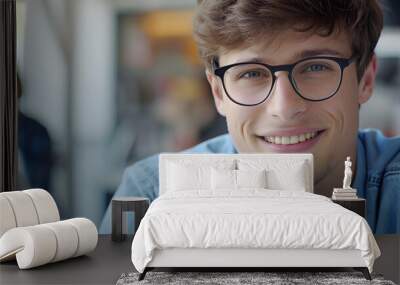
[358,54,378,105]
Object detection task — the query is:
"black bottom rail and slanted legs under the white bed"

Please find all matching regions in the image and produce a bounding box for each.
[138,267,372,281]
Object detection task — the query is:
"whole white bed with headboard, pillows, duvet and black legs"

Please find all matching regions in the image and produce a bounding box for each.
[132,154,380,279]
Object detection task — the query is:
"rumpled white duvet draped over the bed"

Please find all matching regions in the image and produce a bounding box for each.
[132,189,380,272]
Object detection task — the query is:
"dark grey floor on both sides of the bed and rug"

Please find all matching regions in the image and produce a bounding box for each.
[0,235,400,285]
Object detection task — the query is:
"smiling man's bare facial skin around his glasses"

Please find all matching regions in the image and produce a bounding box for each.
[208,31,376,182]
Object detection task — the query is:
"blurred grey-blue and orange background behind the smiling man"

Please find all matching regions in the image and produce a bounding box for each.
[17,0,400,225]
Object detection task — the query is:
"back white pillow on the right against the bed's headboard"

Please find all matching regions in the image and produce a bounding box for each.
[237,159,312,191]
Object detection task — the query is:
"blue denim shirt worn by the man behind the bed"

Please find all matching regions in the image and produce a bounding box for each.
[100,129,400,234]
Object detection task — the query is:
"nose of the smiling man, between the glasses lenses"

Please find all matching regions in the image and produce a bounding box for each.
[266,71,307,121]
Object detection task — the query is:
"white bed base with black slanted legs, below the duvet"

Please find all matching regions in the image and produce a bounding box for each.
[139,248,371,280]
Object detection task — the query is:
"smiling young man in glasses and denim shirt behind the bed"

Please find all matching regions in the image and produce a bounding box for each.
[101,0,400,234]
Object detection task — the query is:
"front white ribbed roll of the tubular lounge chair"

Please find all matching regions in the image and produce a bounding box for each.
[0,218,98,269]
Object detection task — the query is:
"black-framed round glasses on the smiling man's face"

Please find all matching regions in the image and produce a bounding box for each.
[213,56,355,106]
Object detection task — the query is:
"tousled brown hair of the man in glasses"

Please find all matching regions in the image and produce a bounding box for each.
[193,0,383,78]
